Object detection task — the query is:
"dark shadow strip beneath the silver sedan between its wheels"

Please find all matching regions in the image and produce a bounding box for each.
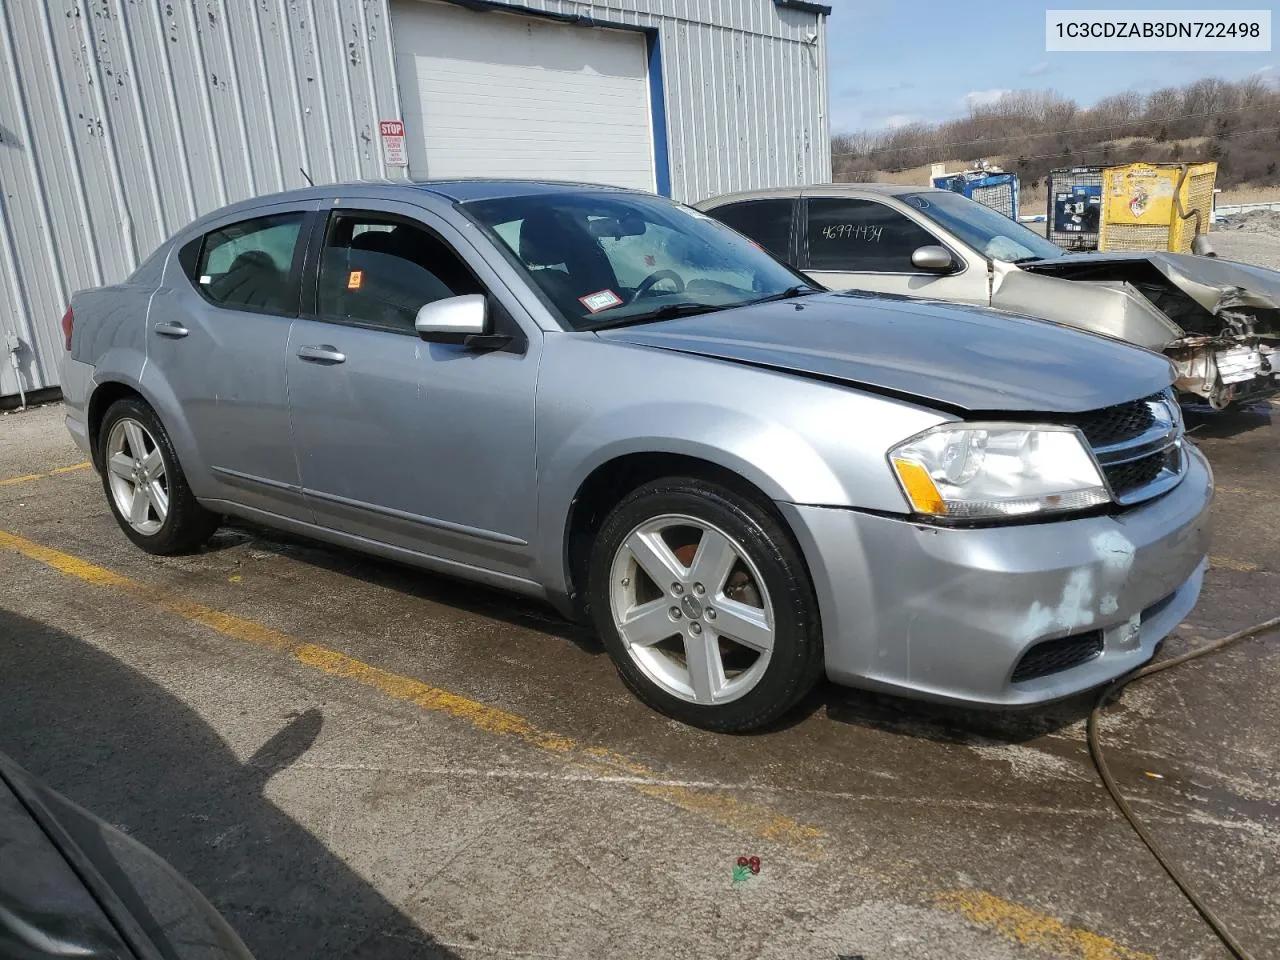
[206,518,604,654]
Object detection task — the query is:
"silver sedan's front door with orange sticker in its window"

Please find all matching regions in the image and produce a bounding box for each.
[287,202,541,577]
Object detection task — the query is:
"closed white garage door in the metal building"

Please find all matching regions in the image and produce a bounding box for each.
[392,0,655,189]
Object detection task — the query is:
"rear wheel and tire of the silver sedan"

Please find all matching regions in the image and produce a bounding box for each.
[97,397,221,556]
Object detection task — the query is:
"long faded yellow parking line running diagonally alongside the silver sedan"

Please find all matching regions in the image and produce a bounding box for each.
[0,530,822,859]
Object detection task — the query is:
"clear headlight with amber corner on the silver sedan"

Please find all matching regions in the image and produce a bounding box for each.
[888,424,1111,520]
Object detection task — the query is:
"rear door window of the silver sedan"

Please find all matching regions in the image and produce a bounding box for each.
[193,212,306,314]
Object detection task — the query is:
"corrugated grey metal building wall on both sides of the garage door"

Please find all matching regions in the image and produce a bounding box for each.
[0,0,831,397]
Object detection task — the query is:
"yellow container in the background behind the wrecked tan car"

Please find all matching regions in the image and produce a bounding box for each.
[1098,163,1217,253]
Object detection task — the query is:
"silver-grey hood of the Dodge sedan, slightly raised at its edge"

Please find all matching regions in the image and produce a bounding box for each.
[598,292,1174,413]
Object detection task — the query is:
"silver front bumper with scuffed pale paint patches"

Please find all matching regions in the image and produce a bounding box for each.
[778,444,1213,707]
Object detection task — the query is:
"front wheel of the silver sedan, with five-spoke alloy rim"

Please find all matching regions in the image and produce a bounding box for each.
[588,477,823,732]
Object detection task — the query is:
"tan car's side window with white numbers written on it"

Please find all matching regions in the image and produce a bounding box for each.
[805,198,938,274]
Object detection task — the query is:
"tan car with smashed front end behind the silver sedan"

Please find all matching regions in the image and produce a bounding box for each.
[698,183,1280,410]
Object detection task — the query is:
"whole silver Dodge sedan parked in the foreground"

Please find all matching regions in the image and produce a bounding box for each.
[63,180,1212,731]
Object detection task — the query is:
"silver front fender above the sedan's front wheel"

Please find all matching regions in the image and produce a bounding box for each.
[535,334,950,593]
